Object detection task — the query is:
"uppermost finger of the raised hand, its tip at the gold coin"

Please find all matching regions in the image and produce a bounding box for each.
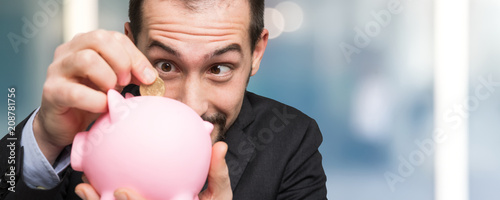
[72,30,156,85]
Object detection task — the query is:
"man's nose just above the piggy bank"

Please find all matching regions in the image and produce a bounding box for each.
[179,78,208,116]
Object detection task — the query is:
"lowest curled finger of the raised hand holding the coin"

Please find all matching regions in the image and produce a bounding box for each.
[47,78,107,113]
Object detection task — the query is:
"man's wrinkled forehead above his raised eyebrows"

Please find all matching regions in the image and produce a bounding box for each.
[142,0,251,43]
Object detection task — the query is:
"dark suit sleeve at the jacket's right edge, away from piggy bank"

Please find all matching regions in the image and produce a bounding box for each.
[277,120,327,200]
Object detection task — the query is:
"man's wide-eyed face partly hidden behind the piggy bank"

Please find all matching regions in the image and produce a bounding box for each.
[125,0,267,142]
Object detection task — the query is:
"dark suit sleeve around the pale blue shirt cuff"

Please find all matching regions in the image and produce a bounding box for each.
[0,111,81,200]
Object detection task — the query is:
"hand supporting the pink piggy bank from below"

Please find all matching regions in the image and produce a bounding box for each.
[75,142,233,200]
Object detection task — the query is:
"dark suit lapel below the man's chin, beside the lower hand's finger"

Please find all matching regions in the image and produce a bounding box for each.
[224,92,255,190]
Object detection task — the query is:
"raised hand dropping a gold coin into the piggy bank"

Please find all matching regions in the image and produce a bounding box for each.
[33,30,157,164]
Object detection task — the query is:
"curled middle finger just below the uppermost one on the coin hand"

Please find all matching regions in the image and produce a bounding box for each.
[61,49,117,92]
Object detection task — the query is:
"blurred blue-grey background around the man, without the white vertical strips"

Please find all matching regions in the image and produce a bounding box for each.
[0,0,500,200]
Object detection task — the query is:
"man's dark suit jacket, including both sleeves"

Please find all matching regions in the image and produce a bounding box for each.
[0,89,326,200]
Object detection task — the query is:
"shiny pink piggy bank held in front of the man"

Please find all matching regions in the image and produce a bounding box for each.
[71,90,213,200]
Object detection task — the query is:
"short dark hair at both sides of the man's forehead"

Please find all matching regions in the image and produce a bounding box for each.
[128,0,264,52]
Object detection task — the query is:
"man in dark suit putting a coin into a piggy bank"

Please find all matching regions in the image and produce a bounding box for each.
[0,0,326,199]
